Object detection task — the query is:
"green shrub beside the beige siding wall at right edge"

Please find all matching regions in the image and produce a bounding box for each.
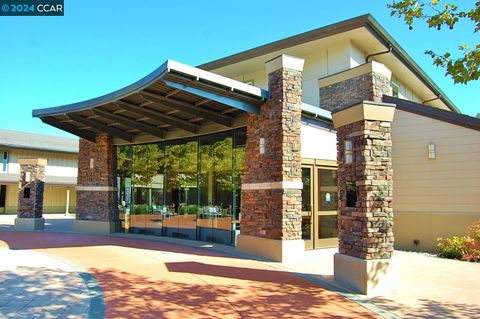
[437,221,480,262]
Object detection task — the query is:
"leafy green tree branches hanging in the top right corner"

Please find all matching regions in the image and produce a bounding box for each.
[388,0,480,84]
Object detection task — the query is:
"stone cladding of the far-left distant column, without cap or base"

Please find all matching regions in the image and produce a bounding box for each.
[17,164,45,218]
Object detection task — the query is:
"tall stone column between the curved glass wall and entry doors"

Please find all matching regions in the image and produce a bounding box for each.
[238,55,305,261]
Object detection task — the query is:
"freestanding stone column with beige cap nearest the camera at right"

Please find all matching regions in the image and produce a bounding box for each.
[332,102,398,295]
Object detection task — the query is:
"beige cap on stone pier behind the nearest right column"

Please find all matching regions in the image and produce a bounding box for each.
[318,61,392,88]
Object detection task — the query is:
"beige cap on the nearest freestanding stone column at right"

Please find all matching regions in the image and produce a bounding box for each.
[332,101,396,128]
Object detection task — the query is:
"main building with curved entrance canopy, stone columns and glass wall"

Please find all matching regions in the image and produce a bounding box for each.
[24,15,480,291]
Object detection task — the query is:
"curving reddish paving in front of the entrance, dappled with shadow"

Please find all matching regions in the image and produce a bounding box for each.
[0,232,378,319]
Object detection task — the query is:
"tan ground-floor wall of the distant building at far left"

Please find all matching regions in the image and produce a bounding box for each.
[0,184,77,214]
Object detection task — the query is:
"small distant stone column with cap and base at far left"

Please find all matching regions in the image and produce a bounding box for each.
[15,158,47,230]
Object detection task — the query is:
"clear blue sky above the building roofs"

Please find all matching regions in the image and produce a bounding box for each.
[0,0,480,136]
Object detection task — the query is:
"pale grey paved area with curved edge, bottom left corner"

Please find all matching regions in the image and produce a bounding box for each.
[0,248,95,319]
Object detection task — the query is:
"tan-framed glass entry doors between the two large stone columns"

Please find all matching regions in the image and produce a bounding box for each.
[302,164,338,249]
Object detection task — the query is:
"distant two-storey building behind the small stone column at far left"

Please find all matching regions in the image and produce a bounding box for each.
[0,130,78,214]
